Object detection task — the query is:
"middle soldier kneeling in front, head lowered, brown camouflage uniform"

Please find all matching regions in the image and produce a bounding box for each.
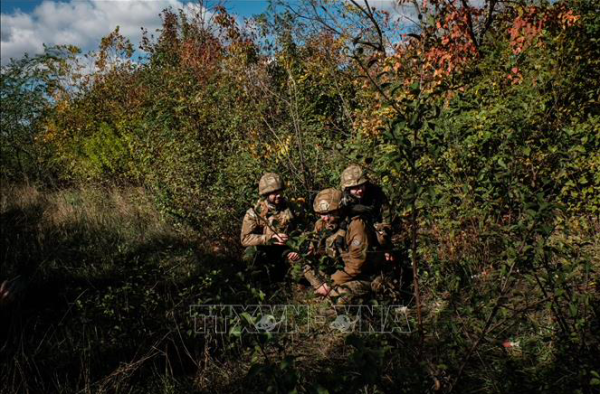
[304,189,381,302]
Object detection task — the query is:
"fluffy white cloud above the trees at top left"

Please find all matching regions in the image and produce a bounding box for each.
[0,0,206,64]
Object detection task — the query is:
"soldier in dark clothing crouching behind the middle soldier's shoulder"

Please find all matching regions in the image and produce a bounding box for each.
[341,164,391,251]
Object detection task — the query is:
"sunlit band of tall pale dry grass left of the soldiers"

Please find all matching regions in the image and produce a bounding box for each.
[1,186,173,278]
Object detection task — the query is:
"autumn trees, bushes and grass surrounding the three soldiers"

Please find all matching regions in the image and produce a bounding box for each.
[0,0,600,393]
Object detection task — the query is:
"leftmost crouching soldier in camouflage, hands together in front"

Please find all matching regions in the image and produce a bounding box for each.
[240,173,300,280]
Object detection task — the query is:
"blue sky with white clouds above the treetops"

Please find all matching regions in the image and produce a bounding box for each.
[0,0,422,65]
